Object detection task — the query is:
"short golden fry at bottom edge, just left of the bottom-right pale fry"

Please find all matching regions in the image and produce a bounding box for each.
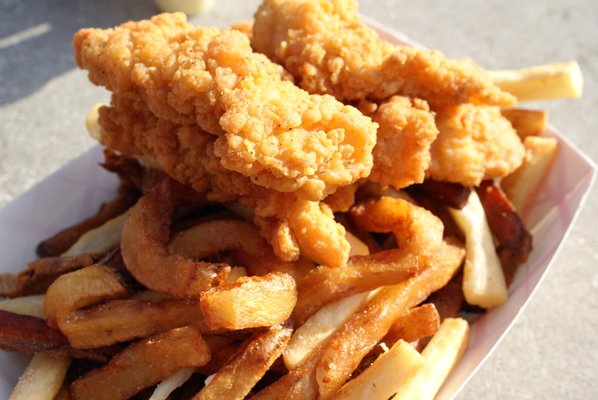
[333,340,426,400]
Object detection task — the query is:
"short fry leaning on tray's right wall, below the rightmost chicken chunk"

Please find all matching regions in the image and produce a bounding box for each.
[501,136,558,212]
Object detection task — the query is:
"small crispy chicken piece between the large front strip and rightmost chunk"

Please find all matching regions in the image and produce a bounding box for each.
[369,96,438,189]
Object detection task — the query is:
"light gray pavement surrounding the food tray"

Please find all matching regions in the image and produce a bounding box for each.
[0,0,598,400]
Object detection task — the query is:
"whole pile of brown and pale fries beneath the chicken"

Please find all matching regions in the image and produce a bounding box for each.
[0,3,578,400]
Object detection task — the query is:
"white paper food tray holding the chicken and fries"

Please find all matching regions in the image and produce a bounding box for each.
[0,18,595,400]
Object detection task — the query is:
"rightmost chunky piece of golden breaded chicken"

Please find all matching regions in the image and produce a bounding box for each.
[427,104,525,186]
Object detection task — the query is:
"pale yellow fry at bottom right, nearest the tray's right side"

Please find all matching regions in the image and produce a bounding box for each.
[392,318,469,400]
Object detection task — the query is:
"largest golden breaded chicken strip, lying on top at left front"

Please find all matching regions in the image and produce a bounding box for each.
[73,14,376,201]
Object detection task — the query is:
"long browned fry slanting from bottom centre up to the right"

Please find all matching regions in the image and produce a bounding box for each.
[316,239,464,398]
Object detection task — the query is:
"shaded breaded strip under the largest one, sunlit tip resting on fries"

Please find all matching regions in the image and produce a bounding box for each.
[98,95,349,266]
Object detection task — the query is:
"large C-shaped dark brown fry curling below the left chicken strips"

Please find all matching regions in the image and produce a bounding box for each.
[121,179,230,297]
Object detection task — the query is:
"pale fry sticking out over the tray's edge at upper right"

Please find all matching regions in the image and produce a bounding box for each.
[489,61,583,101]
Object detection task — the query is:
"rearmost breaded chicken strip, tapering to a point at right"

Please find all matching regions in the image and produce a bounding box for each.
[251,0,515,108]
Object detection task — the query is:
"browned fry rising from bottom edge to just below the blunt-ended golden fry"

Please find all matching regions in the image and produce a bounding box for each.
[193,326,292,400]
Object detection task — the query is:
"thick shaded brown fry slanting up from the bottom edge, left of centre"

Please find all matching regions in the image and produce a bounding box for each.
[71,327,210,400]
